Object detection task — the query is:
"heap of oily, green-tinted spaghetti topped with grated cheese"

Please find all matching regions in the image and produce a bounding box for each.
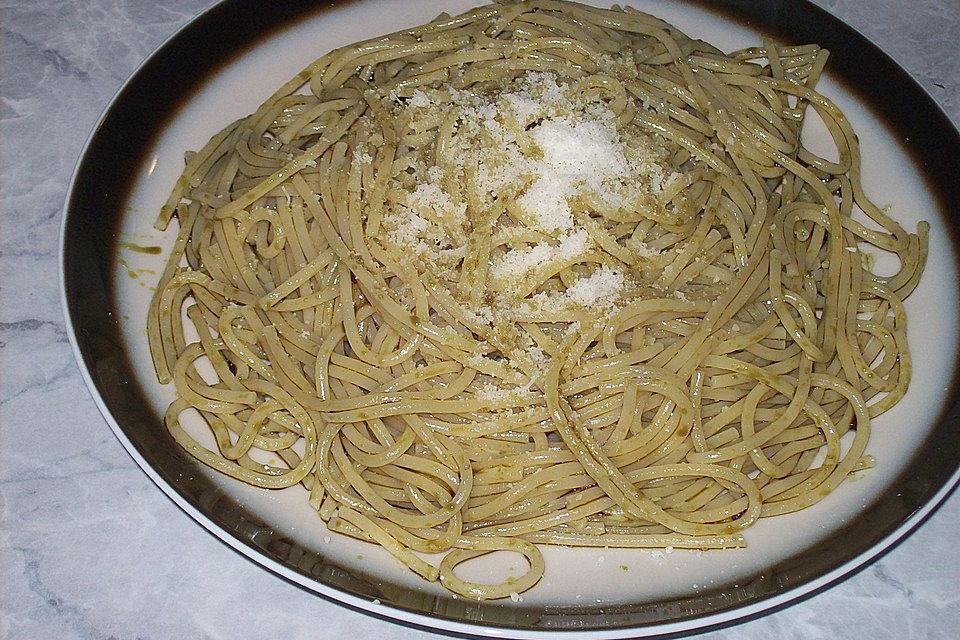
[148,0,927,598]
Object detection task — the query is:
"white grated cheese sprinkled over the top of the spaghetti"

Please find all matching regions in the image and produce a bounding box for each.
[368,67,679,392]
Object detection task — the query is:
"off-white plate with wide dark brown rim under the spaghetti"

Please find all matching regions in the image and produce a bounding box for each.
[61,0,960,638]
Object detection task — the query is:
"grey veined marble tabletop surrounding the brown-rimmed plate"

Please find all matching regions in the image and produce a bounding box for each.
[0,0,960,640]
